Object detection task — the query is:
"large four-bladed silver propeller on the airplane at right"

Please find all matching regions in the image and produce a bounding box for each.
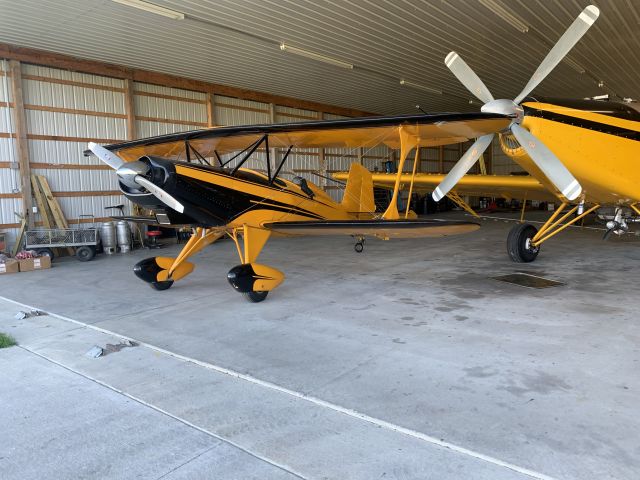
[432,5,600,201]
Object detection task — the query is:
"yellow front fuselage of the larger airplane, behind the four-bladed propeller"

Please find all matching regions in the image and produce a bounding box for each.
[504,102,640,205]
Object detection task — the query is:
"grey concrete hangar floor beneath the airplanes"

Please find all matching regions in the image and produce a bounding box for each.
[0,215,640,479]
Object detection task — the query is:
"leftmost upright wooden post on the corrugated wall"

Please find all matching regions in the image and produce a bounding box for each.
[9,60,33,228]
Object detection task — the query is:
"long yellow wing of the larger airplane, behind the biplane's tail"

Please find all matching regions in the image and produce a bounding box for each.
[333,172,558,202]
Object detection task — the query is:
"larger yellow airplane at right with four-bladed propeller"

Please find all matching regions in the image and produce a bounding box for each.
[334,2,640,262]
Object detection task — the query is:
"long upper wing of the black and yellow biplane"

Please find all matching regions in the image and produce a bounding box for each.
[85,113,512,161]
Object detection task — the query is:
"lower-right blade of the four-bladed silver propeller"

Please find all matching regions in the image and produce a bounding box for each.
[511,124,582,200]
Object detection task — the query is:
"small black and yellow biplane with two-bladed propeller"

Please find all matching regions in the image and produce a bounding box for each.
[87,113,512,302]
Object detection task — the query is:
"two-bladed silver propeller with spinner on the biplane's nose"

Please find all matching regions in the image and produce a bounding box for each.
[89,142,184,213]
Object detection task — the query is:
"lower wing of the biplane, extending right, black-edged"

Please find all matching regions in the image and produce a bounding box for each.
[263,220,480,239]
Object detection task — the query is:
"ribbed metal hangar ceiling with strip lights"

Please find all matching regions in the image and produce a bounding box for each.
[0,0,640,114]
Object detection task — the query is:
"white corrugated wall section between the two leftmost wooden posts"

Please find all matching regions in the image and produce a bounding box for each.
[22,64,127,235]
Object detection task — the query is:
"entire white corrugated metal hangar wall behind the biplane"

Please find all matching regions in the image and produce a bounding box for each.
[0,56,521,251]
